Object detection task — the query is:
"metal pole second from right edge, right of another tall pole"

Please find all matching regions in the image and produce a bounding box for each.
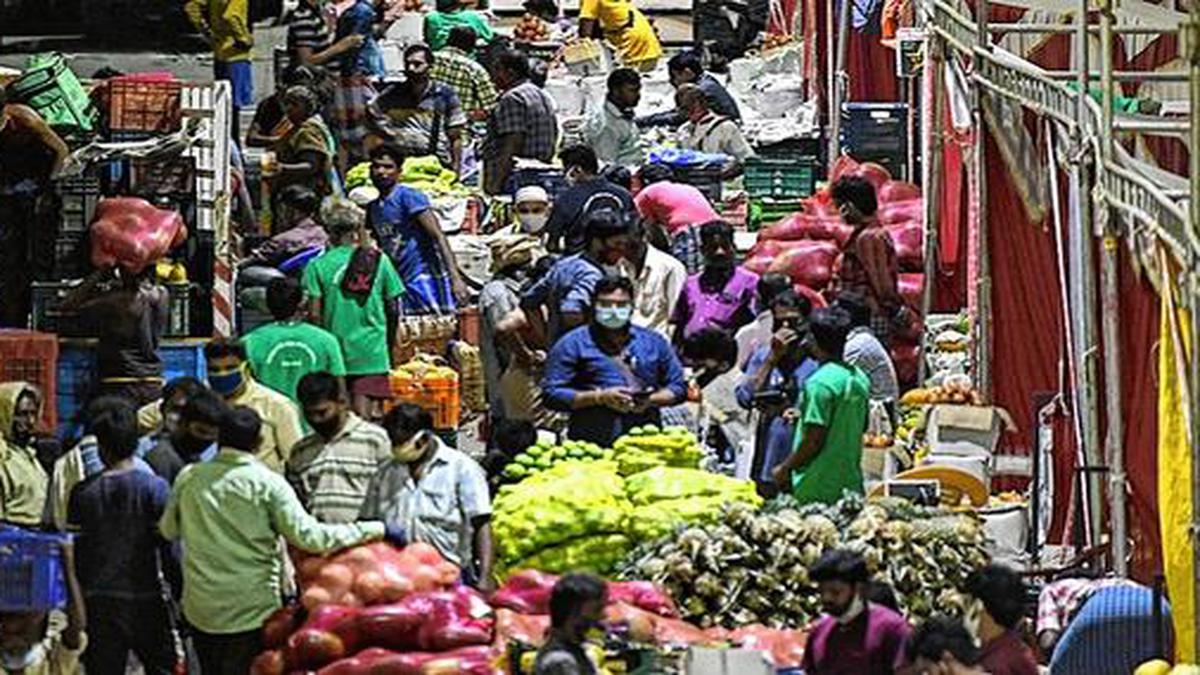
[1096,0,1129,577]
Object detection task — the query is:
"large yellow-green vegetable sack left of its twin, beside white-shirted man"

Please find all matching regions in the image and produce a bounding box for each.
[492,460,631,573]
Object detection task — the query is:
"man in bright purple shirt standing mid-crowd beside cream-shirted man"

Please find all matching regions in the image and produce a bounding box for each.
[671,221,758,345]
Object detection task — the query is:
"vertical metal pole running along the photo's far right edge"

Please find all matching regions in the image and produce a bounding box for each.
[1180,10,1200,655]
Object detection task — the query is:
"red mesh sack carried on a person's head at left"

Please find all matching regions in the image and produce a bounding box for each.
[91,197,187,274]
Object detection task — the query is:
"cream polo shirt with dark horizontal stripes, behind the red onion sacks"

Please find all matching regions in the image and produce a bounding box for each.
[287,412,391,522]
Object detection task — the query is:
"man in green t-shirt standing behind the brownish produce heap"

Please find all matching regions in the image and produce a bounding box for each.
[772,307,871,504]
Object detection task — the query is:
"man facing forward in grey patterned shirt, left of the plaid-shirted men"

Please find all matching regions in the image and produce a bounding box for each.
[368,44,467,174]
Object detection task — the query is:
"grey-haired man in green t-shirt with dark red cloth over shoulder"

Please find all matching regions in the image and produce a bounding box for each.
[304,199,404,420]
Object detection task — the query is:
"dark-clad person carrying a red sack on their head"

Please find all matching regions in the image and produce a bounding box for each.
[61,265,170,406]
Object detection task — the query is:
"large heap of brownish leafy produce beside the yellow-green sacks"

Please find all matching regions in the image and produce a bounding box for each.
[620,497,986,627]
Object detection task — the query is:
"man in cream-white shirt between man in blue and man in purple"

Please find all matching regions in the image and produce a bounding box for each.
[620,222,688,340]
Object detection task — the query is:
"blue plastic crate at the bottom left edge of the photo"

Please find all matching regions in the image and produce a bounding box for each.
[0,526,67,611]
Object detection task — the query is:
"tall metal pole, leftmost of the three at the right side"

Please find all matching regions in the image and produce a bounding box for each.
[1067,0,1103,542]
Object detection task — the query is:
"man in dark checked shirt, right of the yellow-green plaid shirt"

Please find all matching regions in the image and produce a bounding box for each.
[480,50,558,195]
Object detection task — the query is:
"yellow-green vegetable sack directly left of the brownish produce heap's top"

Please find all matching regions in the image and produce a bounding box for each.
[625,466,762,540]
